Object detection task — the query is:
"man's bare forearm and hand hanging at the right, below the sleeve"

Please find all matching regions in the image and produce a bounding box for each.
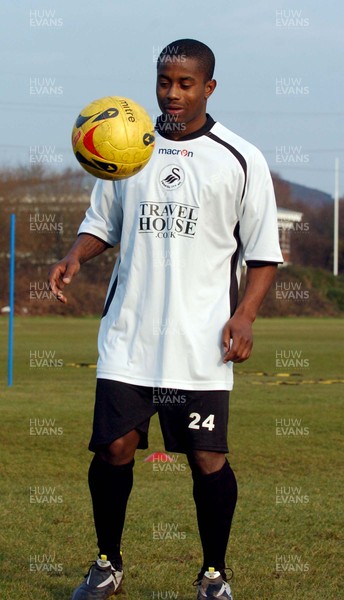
[222,265,277,363]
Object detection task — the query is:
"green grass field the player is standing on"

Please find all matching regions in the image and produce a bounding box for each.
[0,317,344,600]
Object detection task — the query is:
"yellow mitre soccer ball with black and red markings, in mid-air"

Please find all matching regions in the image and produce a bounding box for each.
[72,96,155,180]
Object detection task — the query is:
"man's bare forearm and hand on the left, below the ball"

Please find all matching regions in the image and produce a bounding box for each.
[49,233,111,303]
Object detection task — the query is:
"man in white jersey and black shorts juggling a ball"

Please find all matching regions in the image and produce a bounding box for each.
[50,39,282,600]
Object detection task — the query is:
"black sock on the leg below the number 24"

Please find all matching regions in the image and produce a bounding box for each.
[193,460,238,575]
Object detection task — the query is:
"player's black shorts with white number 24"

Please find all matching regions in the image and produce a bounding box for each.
[89,379,229,454]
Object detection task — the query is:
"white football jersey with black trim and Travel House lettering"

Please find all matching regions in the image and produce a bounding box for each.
[78,116,283,390]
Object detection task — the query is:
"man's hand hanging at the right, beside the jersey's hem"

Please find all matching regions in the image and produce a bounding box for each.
[222,314,253,363]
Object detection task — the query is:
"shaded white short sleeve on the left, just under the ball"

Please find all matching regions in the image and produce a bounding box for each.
[78,179,123,246]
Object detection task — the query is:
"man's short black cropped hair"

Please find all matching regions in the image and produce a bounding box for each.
[157,38,215,81]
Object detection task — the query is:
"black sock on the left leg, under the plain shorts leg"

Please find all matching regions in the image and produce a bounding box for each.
[88,454,134,563]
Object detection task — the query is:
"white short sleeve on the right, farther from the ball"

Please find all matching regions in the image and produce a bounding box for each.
[239,148,283,263]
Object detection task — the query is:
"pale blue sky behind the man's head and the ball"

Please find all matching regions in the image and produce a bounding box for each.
[0,0,344,195]
